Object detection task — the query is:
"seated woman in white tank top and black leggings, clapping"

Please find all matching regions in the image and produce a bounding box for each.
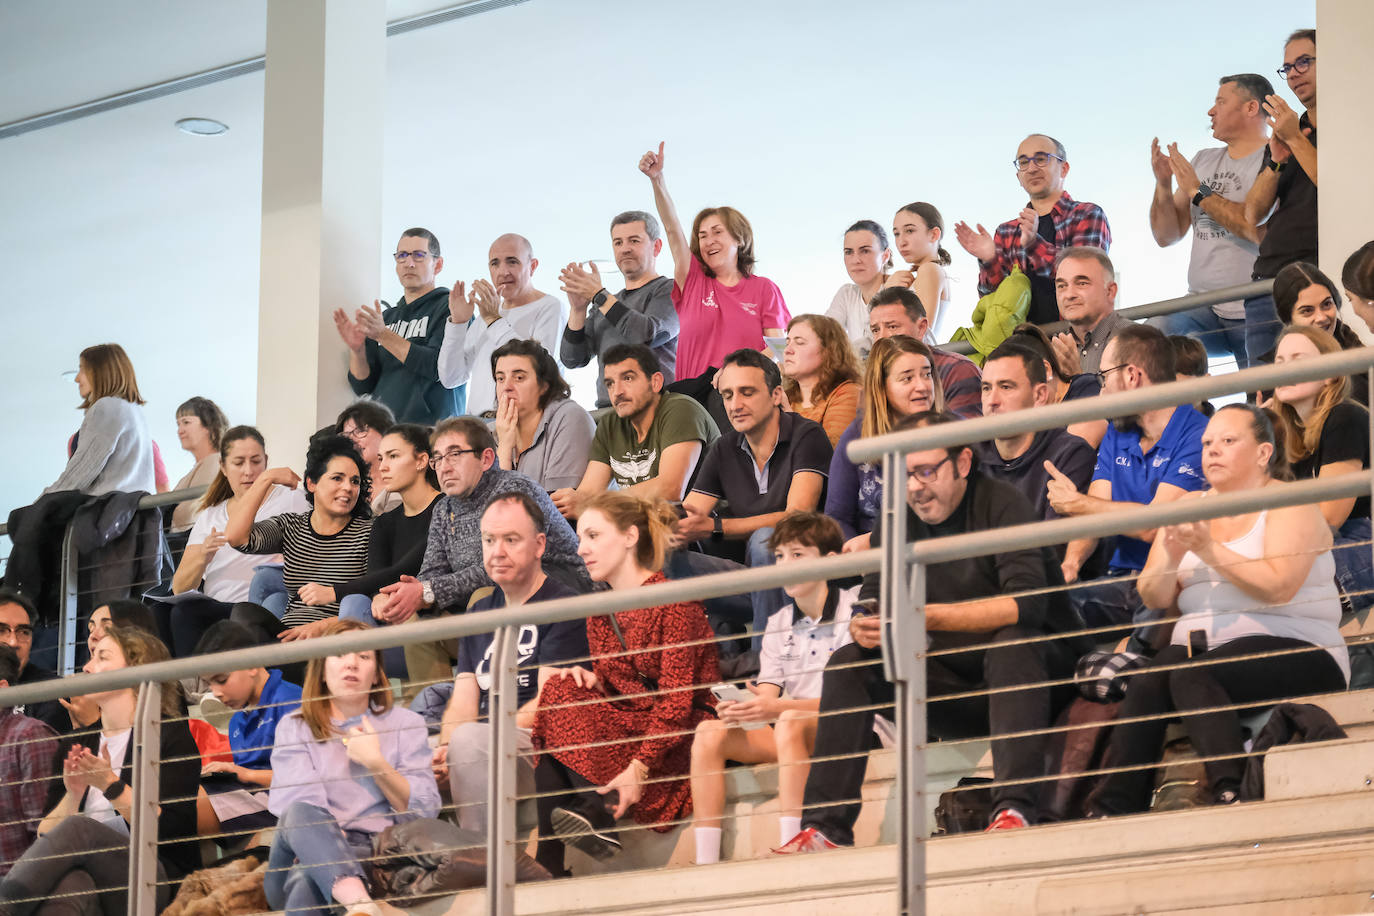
[1091,403,1352,816]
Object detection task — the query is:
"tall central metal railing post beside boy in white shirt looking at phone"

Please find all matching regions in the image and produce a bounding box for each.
[879,452,926,916]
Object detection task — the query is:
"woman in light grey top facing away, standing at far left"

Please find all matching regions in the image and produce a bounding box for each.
[44,343,157,496]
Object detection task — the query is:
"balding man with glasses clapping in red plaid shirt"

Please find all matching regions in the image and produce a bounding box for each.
[954,133,1112,324]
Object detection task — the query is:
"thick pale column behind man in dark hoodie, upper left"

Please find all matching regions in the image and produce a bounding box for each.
[257,0,386,470]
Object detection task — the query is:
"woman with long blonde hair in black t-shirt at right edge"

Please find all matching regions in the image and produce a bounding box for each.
[1272,324,1374,610]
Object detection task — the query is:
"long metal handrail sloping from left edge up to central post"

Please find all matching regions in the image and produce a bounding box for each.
[0,551,881,709]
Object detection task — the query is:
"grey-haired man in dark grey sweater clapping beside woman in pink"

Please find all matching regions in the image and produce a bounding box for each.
[558,210,679,407]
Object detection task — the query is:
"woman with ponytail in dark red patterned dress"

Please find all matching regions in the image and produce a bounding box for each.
[533,492,720,878]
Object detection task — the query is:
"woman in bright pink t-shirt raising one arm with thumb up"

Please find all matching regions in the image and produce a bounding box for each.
[639,143,791,380]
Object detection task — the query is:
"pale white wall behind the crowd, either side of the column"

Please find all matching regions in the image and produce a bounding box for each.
[0,0,1314,512]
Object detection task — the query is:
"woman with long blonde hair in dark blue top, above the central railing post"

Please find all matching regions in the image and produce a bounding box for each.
[826,335,945,551]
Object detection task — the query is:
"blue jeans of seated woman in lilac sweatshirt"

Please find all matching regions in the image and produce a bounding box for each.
[262,802,372,916]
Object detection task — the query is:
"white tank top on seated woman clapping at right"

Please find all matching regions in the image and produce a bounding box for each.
[1172,512,1351,683]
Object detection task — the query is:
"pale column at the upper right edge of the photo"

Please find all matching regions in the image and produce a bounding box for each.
[1316,0,1374,341]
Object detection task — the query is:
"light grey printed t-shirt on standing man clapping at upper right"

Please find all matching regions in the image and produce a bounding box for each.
[1189,146,1264,319]
